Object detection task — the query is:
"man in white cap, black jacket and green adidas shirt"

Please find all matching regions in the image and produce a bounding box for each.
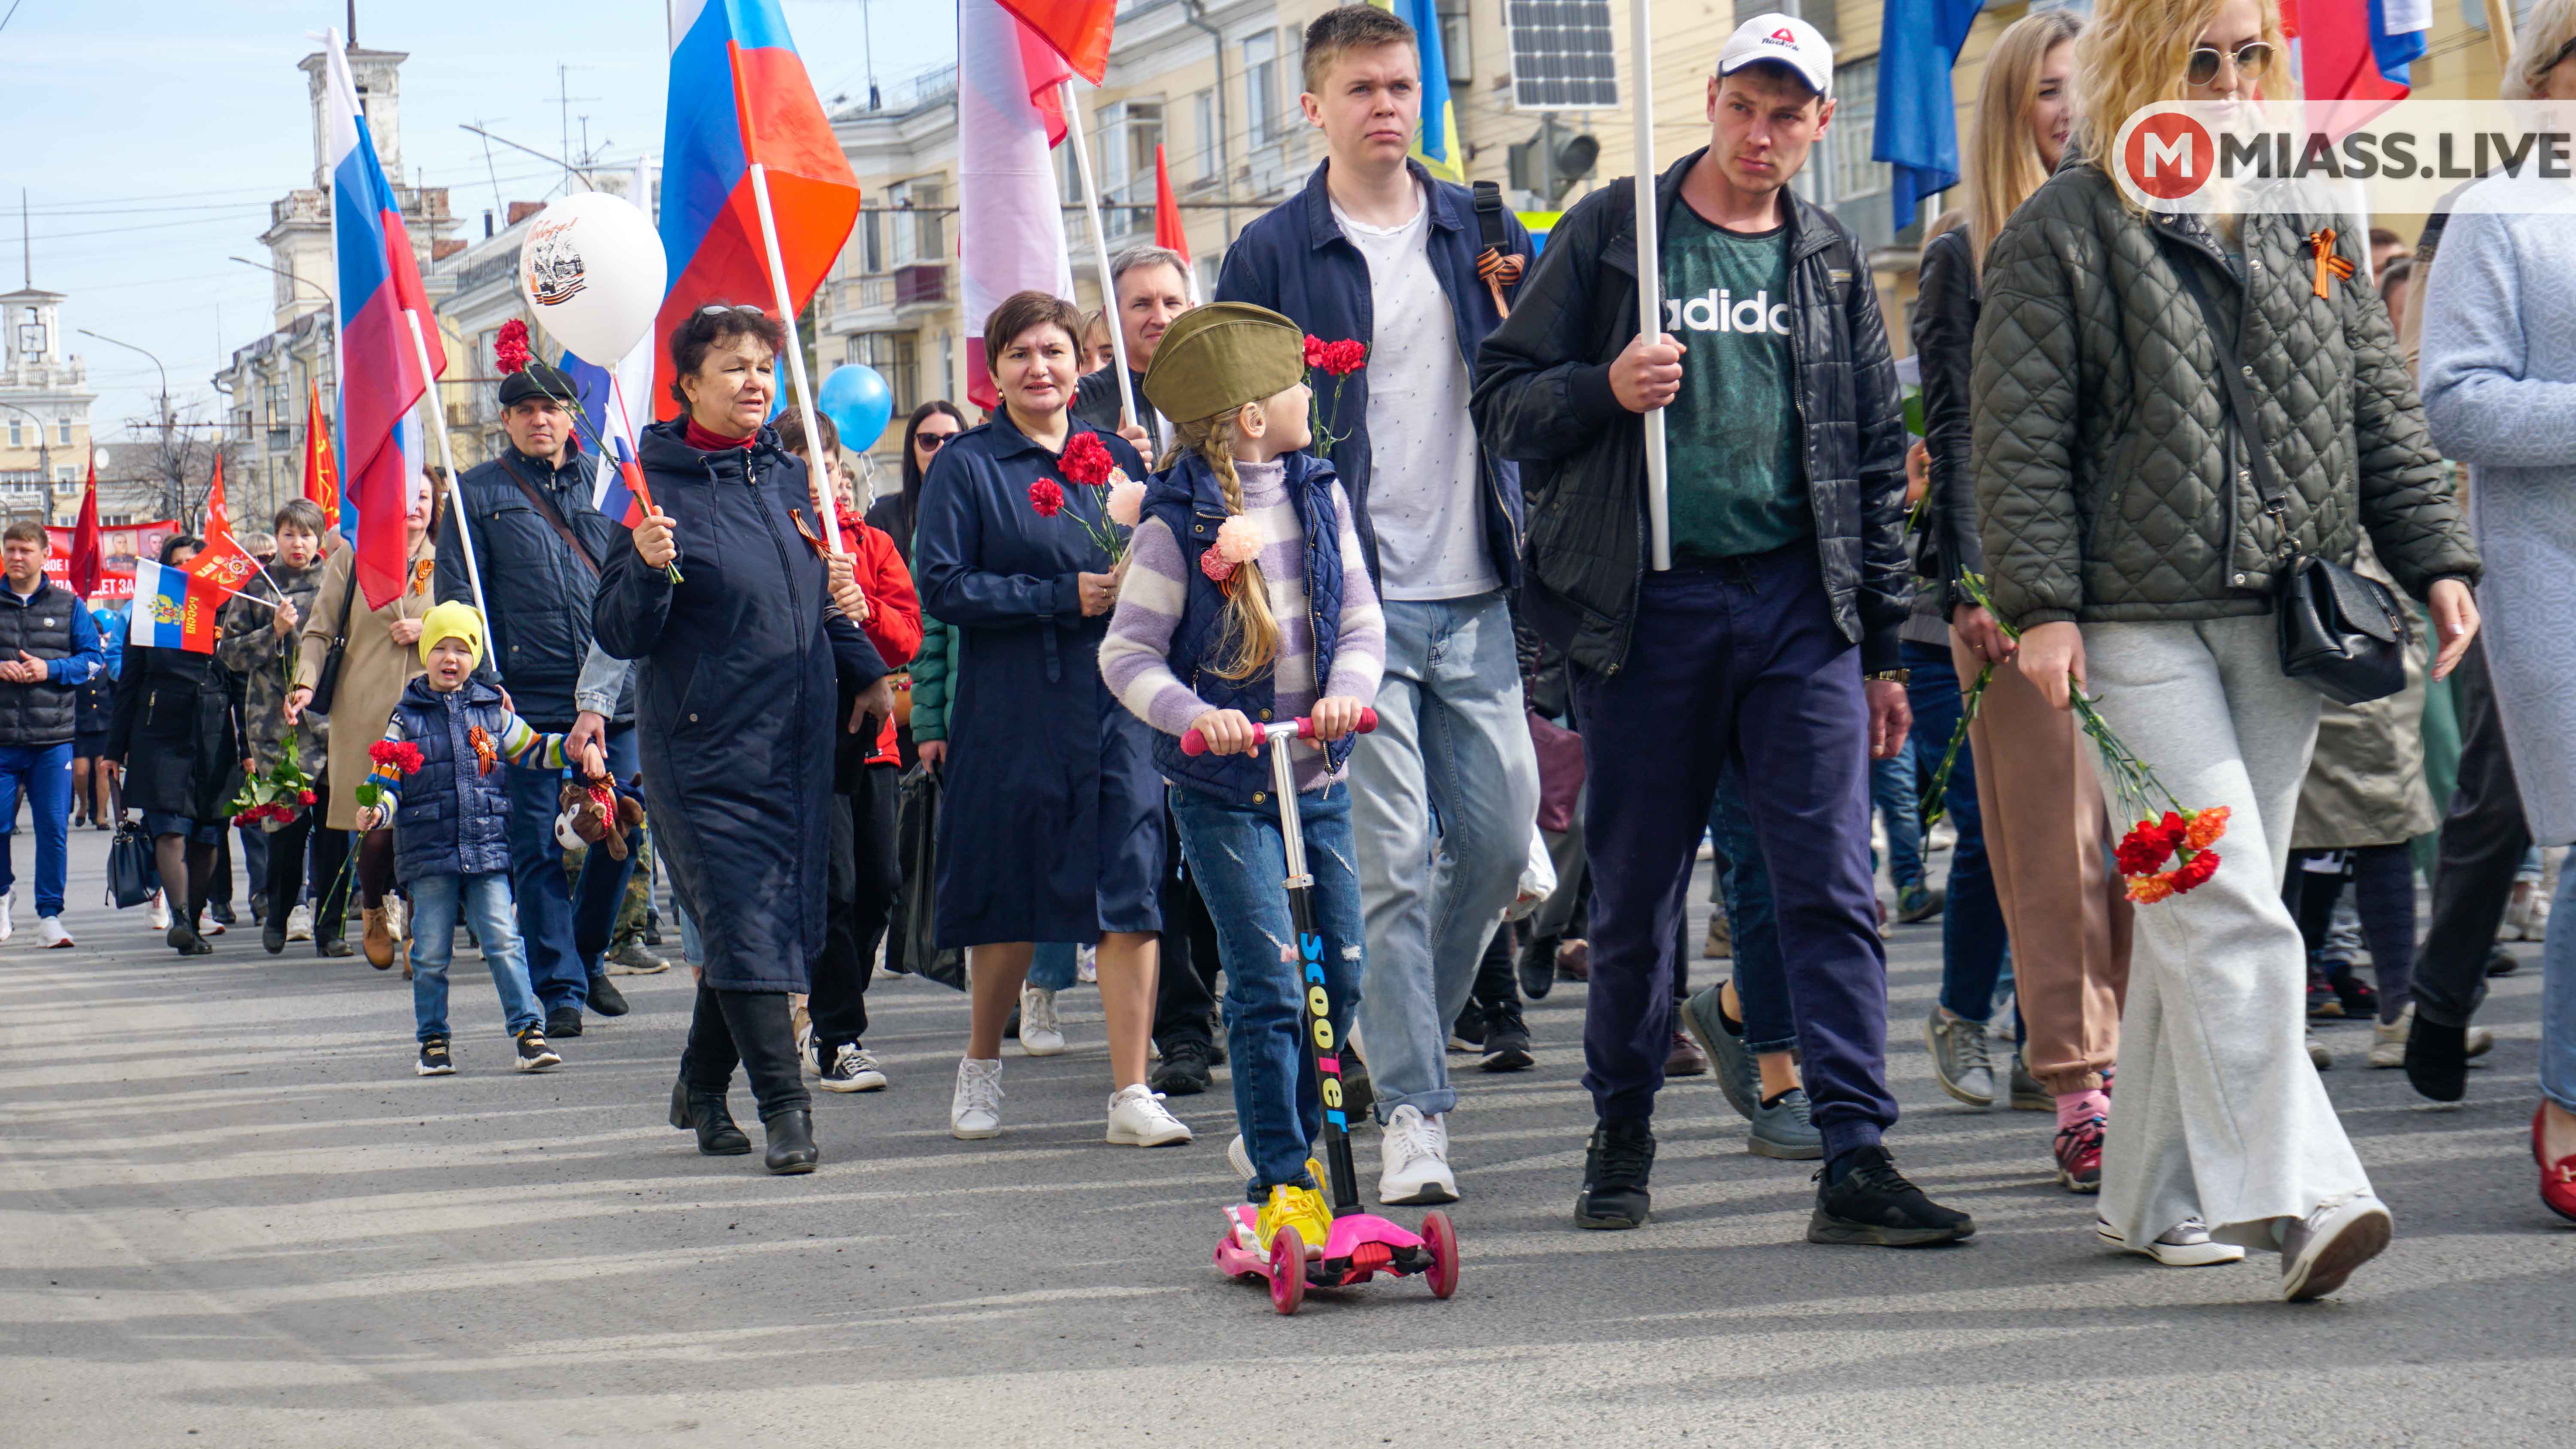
[1473,15,1973,1246]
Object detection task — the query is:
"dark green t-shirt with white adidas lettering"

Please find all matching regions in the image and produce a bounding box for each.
[1664,203,1816,558]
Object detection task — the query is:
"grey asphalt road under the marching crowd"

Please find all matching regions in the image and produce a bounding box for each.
[0,834,2576,1449]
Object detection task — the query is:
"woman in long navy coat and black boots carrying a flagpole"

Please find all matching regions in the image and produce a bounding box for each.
[592,306,891,1171]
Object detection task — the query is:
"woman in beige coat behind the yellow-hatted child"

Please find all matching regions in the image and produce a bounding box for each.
[286,473,446,970]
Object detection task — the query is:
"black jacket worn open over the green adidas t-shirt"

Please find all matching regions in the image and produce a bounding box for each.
[1471,152,1914,674]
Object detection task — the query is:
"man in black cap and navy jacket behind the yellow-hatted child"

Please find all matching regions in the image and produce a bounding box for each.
[438,363,636,1037]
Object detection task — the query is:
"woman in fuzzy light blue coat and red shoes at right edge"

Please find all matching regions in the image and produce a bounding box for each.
[2406,0,2576,1220]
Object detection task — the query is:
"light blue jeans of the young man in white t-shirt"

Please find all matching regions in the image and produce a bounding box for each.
[1350,592,1538,1122]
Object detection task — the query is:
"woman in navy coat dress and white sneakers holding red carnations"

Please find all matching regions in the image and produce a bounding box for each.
[912,291,1190,1148]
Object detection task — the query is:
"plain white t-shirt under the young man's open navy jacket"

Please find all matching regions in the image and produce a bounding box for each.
[1314,185,1502,600]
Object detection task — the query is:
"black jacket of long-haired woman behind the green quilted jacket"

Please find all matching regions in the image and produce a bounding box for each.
[1909,227,1986,643]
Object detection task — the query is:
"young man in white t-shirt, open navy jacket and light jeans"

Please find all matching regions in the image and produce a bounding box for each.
[1216,5,1538,1202]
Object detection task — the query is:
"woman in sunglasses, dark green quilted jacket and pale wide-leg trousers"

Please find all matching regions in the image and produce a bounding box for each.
[1973,0,2478,1300]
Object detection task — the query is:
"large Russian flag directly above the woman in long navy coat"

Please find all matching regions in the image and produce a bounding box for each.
[652,0,858,417]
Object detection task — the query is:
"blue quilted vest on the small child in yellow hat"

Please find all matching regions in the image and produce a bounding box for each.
[394,674,510,883]
